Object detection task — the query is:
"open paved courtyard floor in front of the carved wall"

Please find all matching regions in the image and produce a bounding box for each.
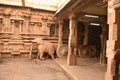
[0,59,70,80]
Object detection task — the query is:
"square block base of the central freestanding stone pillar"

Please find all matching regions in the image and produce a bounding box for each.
[67,54,77,66]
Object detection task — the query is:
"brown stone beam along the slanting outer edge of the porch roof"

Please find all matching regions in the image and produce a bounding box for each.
[56,0,102,18]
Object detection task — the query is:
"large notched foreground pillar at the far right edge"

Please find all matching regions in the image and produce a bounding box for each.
[105,0,120,80]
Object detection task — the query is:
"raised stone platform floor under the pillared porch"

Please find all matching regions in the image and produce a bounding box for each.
[55,58,106,80]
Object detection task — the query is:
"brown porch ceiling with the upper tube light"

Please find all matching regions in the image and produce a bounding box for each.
[55,0,107,22]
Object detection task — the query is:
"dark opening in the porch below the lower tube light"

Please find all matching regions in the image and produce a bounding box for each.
[88,25,102,57]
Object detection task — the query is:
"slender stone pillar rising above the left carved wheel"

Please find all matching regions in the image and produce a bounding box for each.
[58,20,63,46]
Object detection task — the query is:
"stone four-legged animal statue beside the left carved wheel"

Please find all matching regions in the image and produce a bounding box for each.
[34,39,56,59]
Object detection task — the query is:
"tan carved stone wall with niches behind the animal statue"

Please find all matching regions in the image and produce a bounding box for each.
[0,5,56,58]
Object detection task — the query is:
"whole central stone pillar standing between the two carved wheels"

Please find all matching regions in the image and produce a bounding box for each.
[67,14,77,66]
